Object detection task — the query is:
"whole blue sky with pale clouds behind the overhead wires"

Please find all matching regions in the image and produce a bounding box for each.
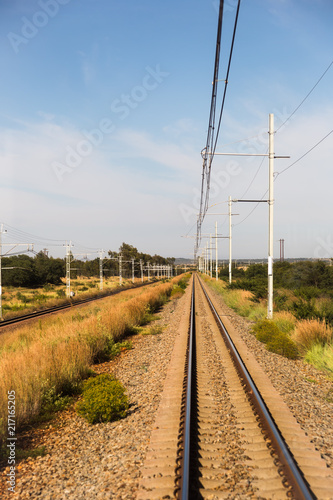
[0,0,333,258]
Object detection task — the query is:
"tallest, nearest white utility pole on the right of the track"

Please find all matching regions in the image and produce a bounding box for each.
[267,114,274,319]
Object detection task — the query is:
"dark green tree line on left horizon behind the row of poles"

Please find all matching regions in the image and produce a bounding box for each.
[1,243,175,288]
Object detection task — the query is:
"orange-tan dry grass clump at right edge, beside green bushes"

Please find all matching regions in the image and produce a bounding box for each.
[292,319,332,353]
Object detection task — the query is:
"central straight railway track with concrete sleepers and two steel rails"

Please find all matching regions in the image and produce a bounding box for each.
[137,276,333,500]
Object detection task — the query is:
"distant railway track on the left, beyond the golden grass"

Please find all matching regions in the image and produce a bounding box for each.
[0,280,160,328]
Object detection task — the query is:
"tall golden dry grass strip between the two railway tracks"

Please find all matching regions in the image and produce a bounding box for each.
[0,276,181,450]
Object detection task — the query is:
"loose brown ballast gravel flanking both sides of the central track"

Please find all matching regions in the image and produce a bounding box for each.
[0,287,333,500]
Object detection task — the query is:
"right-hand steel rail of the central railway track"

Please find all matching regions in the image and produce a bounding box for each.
[199,280,317,500]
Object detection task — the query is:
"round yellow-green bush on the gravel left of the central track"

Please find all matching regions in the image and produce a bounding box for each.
[76,374,129,424]
